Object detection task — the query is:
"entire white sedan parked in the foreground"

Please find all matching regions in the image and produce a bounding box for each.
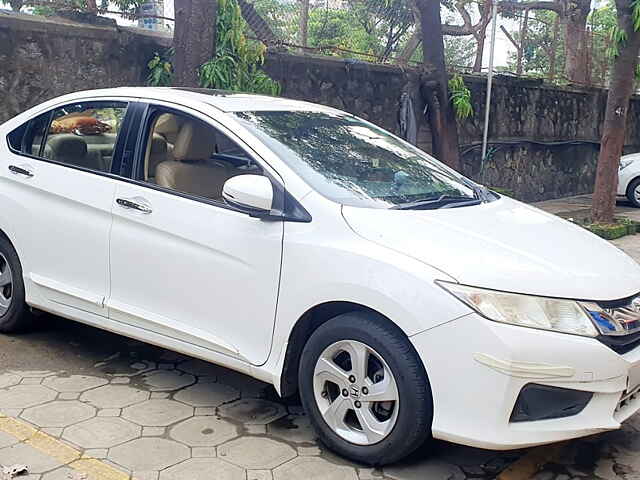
[0,88,640,465]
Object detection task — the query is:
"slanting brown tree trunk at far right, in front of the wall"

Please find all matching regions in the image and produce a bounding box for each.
[591,0,640,223]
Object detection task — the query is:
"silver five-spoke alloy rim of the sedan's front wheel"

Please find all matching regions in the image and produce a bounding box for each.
[313,340,400,445]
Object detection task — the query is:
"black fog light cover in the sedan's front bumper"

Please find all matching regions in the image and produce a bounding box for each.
[510,383,593,422]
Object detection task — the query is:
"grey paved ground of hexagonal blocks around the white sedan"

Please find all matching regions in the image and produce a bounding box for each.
[0,197,640,480]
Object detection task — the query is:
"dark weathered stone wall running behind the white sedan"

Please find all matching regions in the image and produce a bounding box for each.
[0,13,640,201]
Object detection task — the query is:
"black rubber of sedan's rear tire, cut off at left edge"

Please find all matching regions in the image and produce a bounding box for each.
[0,236,33,333]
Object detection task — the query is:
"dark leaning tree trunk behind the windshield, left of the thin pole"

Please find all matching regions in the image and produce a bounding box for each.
[416,0,460,171]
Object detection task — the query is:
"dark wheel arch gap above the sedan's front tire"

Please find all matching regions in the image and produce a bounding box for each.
[280,301,404,397]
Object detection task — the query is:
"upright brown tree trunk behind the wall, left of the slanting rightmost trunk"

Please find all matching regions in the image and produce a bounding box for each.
[564,0,591,84]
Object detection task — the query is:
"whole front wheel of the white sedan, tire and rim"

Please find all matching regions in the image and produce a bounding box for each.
[299,312,433,465]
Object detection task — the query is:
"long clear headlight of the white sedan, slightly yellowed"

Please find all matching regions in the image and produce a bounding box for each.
[438,282,598,337]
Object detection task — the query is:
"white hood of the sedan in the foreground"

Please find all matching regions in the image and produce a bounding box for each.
[342,197,640,300]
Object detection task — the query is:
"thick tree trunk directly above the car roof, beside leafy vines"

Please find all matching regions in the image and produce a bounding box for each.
[173,0,218,87]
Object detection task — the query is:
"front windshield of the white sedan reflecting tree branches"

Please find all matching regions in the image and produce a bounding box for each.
[235,111,478,208]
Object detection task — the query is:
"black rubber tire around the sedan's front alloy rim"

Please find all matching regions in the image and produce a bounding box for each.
[298,312,433,466]
